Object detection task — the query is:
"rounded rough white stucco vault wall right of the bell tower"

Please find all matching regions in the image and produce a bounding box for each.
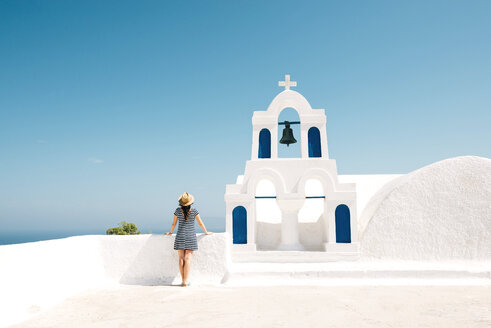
[361,156,491,261]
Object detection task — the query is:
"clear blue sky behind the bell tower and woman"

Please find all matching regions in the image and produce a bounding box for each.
[0,0,491,236]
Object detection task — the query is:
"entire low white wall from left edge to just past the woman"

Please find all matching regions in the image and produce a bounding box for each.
[0,233,230,327]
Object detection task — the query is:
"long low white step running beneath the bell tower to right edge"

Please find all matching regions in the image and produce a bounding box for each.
[224,262,491,285]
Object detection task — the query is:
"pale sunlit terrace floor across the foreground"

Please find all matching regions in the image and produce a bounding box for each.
[12,285,491,328]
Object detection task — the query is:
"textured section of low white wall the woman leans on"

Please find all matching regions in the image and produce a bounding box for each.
[100,233,233,285]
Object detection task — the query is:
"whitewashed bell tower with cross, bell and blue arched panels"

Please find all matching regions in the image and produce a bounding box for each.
[225,75,359,256]
